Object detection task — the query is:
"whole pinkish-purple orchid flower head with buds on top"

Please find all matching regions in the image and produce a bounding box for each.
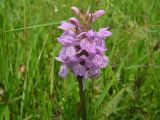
[56,7,112,78]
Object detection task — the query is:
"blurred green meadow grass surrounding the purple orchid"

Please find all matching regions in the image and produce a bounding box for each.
[0,0,160,120]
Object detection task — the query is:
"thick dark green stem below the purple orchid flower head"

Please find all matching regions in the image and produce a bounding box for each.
[77,76,87,120]
